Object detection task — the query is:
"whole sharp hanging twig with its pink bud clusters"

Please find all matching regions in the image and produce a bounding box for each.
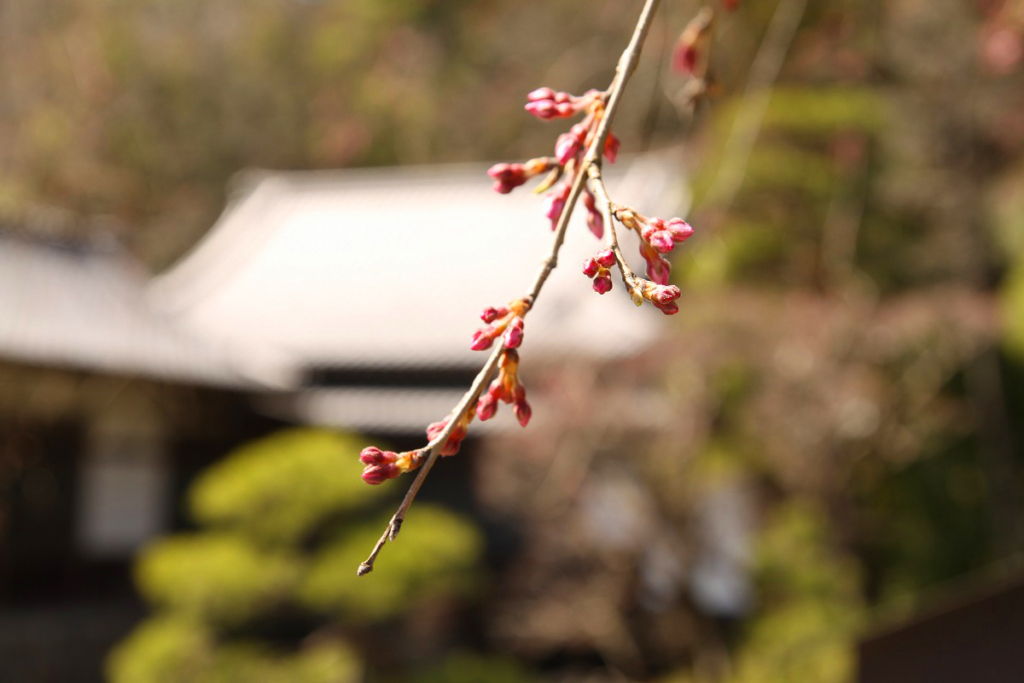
[358,0,712,575]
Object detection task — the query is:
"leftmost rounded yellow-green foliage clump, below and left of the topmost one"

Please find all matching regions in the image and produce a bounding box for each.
[135,532,301,624]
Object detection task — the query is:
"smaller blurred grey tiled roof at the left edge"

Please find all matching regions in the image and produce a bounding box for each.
[0,231,280,387]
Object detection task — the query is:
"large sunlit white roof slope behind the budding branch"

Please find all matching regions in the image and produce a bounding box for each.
[151,154,683,367]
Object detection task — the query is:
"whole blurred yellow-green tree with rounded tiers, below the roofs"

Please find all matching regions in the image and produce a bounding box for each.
[109,429,487,683]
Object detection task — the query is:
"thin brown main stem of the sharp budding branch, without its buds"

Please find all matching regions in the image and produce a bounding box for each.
[356,0,659,577]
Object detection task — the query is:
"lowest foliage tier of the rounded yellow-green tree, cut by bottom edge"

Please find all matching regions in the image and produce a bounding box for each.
[106,617,360,683]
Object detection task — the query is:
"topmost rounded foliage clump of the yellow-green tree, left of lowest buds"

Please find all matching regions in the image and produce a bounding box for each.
[189,429,387,544]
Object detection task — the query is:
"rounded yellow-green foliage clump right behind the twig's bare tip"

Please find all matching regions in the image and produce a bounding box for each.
[300,504,482,620]
